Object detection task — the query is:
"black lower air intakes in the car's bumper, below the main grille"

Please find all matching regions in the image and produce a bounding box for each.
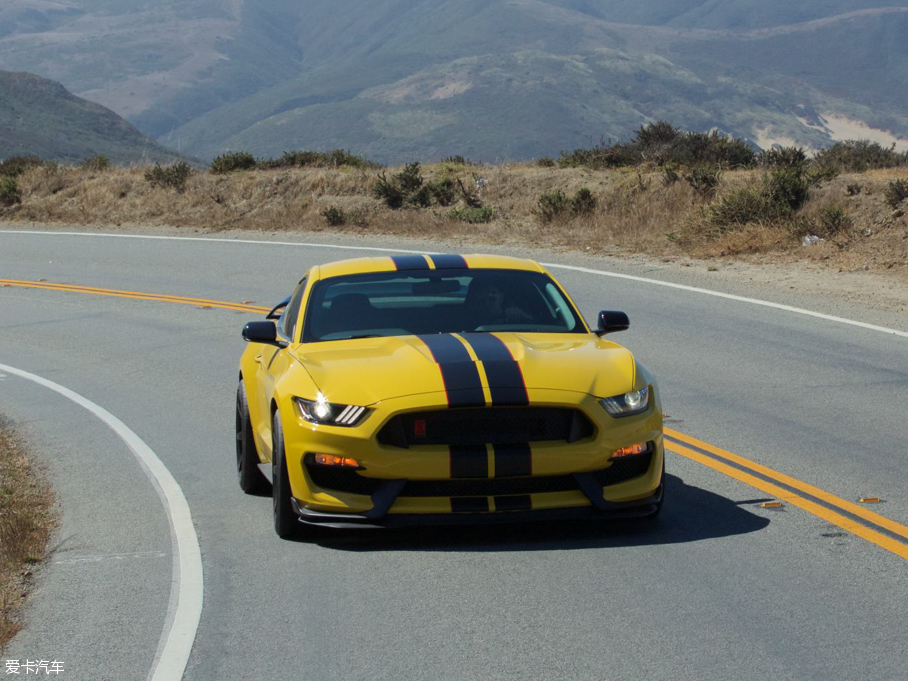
[306,451,653,497]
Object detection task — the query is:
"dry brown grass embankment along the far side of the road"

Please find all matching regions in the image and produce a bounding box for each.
[0,164,908,271]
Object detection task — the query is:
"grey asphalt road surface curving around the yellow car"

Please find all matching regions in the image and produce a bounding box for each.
[0,231,908,681]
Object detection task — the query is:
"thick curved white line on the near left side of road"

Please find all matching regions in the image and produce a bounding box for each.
[0,364,203,681]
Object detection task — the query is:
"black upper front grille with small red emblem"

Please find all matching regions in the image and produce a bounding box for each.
[378,407,594,448]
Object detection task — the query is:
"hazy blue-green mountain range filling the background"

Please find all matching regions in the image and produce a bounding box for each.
[0,0,908,163]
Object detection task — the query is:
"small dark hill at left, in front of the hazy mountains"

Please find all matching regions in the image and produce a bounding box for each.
[0,71,183,163]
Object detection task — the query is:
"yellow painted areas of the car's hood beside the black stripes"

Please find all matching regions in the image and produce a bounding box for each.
[296,333,635,406]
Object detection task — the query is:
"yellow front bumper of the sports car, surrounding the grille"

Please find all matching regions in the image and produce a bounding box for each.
[282,390,664,527]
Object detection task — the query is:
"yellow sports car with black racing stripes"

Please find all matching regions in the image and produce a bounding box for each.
[236,255,665,537]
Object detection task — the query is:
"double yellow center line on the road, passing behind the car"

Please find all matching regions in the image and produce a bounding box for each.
[0,279,908,560]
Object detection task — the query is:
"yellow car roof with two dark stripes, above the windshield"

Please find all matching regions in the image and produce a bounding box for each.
[319,253,545,279]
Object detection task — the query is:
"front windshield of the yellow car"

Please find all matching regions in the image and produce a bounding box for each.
[303,269,586,343]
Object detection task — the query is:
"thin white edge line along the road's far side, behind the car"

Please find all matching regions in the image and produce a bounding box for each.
[0,229,908,338]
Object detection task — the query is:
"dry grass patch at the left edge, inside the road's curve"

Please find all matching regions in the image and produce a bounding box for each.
[0,423,54,650]
